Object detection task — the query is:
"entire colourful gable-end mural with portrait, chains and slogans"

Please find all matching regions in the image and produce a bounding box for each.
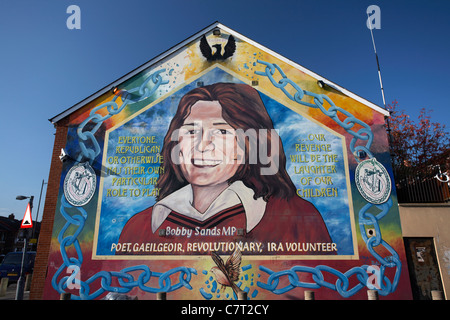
[44,25,411,299]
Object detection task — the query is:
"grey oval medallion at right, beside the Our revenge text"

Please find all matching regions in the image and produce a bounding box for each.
[355,158,392,204]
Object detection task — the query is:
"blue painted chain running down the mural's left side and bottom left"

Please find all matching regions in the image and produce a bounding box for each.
[51,69,197,300]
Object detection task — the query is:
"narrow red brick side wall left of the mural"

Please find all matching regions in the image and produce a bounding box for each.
[30,118,69,300]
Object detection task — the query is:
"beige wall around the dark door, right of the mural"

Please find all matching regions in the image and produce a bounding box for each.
[399,204,450,299]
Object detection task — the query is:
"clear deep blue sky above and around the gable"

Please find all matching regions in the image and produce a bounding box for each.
[0,0,450,221]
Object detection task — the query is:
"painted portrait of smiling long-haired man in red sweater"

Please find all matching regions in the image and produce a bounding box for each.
[119,83,332,254]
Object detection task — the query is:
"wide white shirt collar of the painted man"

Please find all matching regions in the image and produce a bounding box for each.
[152,181,266,233]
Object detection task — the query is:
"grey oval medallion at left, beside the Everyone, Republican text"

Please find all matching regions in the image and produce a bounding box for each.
[64,162,97,207]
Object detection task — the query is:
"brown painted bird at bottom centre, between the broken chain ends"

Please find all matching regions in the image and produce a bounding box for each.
[211,249,242,295]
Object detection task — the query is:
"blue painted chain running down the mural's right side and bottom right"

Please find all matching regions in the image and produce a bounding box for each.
[255,60,402,298]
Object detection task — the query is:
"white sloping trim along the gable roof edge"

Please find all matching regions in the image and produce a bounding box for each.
[49,22,389,123]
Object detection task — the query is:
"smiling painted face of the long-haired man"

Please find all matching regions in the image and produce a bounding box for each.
[178,101,244,186]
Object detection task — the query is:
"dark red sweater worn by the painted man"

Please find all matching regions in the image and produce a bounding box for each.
[116,196,336,255]
